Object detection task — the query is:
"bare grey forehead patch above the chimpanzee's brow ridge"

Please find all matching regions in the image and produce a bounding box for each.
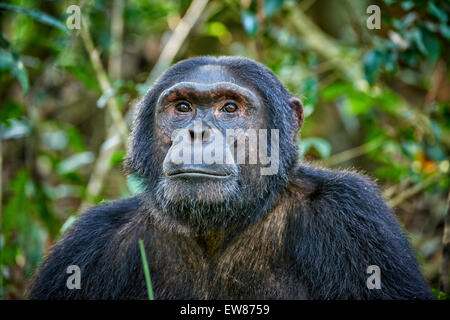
[183,65,239,84]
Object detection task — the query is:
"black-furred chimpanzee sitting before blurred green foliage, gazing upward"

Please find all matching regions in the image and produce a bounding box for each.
[28,57,432,299]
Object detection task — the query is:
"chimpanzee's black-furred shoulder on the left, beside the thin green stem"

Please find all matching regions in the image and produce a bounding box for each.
[27,197,141,300]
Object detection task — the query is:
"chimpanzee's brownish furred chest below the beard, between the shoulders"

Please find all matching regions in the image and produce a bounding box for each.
[144,224,306,299]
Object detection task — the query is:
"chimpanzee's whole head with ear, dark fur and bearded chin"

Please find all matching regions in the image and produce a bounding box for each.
[127,57,303,228]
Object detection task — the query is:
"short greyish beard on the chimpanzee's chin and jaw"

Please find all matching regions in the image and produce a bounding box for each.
[149,168,282,233]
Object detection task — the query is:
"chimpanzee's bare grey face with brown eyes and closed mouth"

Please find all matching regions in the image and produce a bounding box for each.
[155,65,276,203]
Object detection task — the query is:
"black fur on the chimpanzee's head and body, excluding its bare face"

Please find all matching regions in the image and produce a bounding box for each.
[28,57,432,299]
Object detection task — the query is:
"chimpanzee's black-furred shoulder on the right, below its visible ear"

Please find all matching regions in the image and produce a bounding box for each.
[288,164,432,299]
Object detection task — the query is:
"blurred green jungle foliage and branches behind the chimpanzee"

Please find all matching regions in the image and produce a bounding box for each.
[0,0,450,299]
